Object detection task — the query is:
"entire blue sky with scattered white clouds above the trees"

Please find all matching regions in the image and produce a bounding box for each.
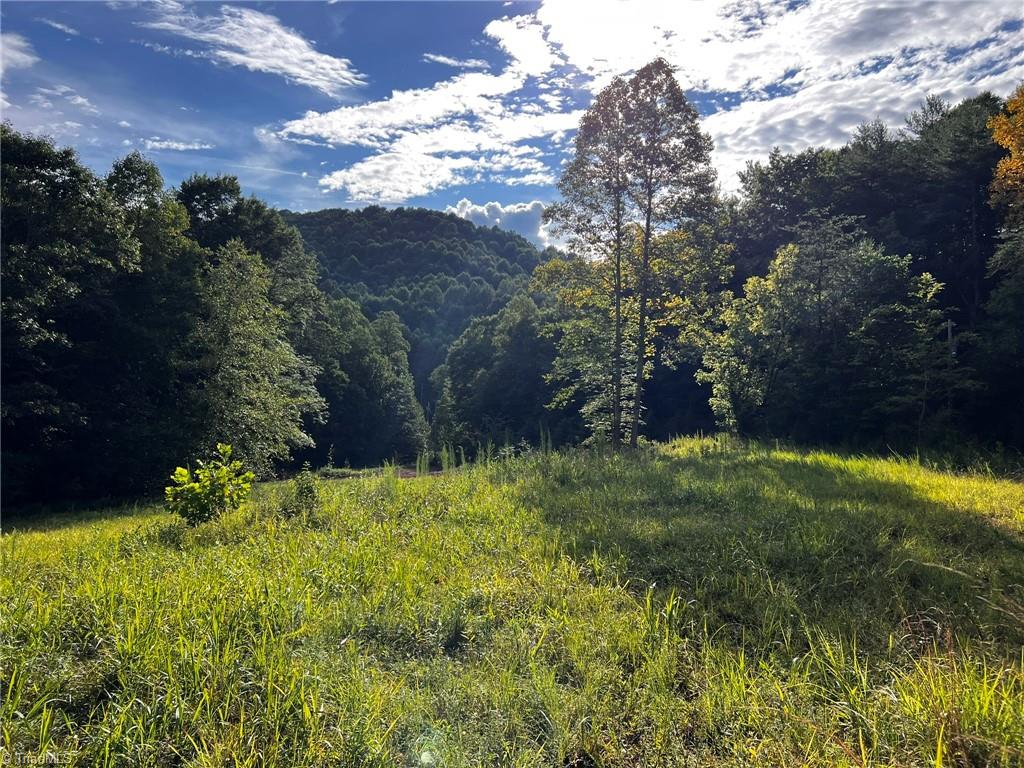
[0,0,1024,245]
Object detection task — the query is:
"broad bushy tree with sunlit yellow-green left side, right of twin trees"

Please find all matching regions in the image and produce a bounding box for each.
[700,217,946,443]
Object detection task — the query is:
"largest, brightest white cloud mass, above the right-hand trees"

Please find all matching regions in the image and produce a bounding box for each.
[537,0,1024,187]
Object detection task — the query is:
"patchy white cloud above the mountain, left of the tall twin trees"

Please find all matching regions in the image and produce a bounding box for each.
[281,15,580,203]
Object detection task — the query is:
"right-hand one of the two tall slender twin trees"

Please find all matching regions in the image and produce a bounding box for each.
[626,58,715,447]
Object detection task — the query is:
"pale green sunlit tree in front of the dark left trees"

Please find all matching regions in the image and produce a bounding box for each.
[185,241,324,476]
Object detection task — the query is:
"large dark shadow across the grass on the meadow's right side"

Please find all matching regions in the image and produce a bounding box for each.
[520,451,1024,653]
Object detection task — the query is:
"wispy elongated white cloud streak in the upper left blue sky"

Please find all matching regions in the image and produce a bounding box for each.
[142,0,365,98]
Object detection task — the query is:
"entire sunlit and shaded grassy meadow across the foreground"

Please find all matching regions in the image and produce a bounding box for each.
[0,439,1024,768]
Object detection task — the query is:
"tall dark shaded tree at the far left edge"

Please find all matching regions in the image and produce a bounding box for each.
[0,124,139,500]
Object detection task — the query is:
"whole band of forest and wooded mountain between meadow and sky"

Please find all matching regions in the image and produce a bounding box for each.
[2,60,1024,504]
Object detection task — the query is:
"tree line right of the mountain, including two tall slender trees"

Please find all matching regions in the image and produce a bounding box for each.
[432,60,1024,450]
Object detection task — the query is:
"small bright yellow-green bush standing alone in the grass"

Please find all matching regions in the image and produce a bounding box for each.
[164,442,255,525]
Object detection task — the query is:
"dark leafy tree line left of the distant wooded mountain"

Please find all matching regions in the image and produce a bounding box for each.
[0,125,428,504]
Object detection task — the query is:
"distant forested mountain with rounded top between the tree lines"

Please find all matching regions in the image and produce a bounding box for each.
[283,206,542,399]
